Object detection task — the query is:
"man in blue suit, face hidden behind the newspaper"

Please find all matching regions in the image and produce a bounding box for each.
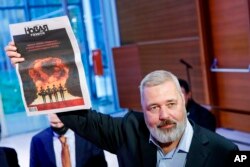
[30,114,107,167]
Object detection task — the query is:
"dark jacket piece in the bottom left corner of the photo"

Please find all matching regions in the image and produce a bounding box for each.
[0,147,19,167]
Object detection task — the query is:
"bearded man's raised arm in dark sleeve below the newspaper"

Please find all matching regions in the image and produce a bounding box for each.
[57,110,124,153]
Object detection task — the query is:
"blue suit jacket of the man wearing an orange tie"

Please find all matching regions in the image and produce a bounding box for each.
[30,128,107,167]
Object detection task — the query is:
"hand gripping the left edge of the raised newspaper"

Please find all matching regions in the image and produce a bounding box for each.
[5,41,24,65]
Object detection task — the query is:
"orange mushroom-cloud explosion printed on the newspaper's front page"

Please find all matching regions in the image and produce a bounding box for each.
[29,57,72,104]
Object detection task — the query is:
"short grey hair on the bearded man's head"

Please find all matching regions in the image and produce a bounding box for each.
[139,70,181,97]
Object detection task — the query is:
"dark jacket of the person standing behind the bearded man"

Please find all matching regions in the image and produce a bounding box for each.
[187,99,216,132]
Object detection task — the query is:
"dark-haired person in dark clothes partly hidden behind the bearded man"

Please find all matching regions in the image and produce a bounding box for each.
[179,79,216,132]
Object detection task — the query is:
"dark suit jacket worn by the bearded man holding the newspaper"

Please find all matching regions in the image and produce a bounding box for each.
[58,110,238,167]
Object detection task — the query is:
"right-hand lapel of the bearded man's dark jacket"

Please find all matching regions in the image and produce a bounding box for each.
[186,124,210,167]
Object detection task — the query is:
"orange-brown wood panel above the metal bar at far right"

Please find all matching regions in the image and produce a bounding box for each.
[209,0,250,65]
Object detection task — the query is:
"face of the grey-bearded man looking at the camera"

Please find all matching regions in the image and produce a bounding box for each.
[142,81,186,143]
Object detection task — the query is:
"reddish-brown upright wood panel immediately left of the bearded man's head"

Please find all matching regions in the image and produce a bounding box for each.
[113,45,142,110]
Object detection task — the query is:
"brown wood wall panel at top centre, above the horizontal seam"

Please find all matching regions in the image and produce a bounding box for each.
[116,0,198,45]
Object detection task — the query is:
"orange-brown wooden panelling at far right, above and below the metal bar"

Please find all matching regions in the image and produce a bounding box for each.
[209,0,250,110]
